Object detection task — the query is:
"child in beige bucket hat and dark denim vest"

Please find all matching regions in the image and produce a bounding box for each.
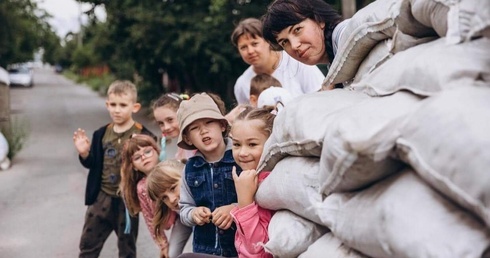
[177,93,243,257]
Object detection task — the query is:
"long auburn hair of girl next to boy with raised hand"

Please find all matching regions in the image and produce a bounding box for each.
[119,134,160,216]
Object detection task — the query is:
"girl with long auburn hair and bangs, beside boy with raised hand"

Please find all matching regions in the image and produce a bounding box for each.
[119,134,181,257]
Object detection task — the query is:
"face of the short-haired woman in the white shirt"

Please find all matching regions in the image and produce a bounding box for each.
[237,34,271,66]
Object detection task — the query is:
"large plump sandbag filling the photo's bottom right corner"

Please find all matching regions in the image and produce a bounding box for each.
[321,169,490,258]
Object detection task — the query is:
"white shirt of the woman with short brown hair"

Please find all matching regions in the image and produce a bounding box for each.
[235,51,325,104]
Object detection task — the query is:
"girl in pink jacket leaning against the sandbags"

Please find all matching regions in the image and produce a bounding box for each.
[230,107,275,257]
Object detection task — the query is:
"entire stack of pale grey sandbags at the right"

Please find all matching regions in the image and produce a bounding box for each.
[256,0,490,257]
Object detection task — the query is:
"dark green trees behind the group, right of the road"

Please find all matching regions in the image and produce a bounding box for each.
[76,0,367,104]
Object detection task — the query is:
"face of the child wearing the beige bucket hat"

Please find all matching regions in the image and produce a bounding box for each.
[184,118,226,155]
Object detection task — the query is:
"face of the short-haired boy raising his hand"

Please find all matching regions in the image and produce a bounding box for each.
[106,93,141,125]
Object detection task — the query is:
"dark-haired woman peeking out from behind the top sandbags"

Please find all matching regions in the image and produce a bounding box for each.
[262,0,347,65]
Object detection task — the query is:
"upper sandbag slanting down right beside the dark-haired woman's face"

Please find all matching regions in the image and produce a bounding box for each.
[323,0,437,87]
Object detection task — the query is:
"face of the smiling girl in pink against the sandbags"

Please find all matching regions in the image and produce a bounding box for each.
[230,119,269,170]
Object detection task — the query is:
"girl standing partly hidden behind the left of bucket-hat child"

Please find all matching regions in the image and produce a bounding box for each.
[152,93,195,161]
